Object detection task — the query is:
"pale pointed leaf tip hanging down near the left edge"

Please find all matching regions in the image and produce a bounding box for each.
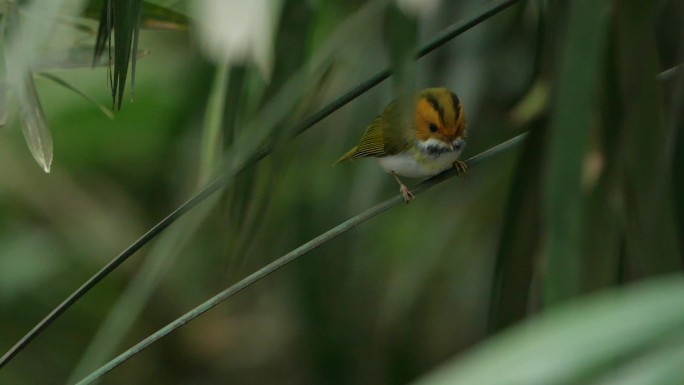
[17,75,52,172]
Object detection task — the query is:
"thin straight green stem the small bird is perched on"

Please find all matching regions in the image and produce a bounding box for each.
[77,133,527,385]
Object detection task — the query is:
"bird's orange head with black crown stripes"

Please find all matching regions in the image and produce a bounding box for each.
[415,88,466,155]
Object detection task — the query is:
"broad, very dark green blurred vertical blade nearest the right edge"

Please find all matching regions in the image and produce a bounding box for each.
[616,0,681,277]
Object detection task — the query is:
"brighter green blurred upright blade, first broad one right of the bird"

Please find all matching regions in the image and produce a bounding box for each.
[543,0,611,305]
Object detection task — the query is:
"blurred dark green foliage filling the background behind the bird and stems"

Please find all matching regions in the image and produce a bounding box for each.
[0,0,684,384]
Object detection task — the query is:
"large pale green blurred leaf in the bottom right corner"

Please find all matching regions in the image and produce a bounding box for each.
[416,276,684,385]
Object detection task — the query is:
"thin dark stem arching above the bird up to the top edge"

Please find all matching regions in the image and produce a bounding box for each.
[0,0,520,369]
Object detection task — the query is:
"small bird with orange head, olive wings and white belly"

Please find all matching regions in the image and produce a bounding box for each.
[335,88,468,203]
